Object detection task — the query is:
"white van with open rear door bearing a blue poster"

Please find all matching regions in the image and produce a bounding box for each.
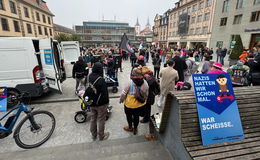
[0,37,65,105]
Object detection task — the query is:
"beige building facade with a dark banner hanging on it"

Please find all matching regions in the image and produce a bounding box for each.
[167,0,217,48]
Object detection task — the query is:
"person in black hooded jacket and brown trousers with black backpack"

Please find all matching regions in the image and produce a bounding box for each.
[84,62,109,140]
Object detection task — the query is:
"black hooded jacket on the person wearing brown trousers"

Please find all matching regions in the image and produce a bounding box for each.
[85,62,109,107]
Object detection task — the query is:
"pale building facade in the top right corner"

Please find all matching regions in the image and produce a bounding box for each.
[210,0,260,49]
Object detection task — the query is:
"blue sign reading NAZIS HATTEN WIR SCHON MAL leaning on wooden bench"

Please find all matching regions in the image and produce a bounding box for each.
[192,73,244,145]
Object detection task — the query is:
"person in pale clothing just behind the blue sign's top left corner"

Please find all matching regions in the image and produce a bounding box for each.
[184,53,199,82]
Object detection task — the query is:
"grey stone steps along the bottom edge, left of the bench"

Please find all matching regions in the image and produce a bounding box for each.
[1,136,173,160]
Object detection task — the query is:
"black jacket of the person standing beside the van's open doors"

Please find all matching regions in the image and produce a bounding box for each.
[72,61,88,78]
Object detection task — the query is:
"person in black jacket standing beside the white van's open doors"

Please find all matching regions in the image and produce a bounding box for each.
[72,56,89,92]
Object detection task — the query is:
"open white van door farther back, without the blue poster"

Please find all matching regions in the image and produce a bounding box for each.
[61,41,80,77]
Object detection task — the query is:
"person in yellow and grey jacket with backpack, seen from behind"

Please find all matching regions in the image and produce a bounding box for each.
[120,67,149,135]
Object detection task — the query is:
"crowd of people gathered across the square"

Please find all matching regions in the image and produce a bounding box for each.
[73,41,260,140]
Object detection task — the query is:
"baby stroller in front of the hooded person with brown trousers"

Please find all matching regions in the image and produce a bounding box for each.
[74,90,113,123]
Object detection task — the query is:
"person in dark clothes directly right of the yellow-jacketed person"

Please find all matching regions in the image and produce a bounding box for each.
[140,69,160,123]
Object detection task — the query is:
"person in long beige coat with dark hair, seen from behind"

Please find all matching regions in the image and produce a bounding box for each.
[157,60,179,108]
